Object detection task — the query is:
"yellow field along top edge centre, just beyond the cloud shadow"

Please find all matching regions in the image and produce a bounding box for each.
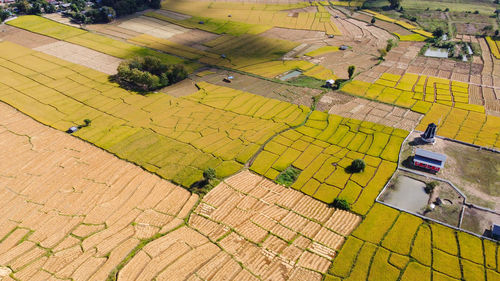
[162,0,341,35]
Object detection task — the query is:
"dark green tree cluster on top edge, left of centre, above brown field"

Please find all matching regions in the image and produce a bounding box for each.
[66,0,161,23]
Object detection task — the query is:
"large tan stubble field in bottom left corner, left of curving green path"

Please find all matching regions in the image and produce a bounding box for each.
[0,103,198,280]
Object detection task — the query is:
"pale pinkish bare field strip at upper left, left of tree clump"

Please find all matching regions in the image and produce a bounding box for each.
[33,41,122,75]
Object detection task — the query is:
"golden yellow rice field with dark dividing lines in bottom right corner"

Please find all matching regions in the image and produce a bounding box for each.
[326,204,500,281]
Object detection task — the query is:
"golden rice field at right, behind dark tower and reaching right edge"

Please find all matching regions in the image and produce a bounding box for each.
[342,73,500,148]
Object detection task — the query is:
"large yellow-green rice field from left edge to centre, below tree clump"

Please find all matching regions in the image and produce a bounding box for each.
[0,42,309,186]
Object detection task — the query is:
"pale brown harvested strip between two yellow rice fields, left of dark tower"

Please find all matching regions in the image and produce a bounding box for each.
[320,94,422,131]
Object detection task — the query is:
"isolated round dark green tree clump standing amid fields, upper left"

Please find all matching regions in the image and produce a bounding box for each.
[115,56,188,92]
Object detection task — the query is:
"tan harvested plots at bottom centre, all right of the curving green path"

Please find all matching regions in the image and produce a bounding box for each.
[123,171,361,281]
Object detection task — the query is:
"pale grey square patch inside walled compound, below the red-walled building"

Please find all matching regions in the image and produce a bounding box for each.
[384,176,429,213]
